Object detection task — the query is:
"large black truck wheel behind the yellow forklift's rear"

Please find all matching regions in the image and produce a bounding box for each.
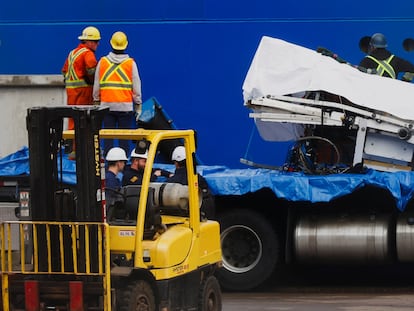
[216,209,279,291]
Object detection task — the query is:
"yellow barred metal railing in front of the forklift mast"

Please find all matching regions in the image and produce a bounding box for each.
[0,221,111,311]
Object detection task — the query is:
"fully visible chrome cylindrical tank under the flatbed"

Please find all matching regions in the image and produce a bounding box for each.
[294,214,394,264]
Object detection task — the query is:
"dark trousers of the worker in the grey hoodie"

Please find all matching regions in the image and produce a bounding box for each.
[103,111,134,157]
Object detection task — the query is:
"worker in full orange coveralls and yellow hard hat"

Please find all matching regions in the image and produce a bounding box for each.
[62,26,101,129]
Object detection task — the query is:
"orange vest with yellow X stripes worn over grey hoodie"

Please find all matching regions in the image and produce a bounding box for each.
[99,57,134,103]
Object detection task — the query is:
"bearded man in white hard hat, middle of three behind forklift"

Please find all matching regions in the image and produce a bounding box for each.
[122,149,171,186]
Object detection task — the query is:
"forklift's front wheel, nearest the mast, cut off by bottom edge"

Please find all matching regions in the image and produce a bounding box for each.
[117,280,156,311]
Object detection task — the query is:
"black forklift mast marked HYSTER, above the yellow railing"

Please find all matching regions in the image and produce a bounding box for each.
[26,106,109,222]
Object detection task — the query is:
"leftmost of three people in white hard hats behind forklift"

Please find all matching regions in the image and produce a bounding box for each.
[105,147,128,206]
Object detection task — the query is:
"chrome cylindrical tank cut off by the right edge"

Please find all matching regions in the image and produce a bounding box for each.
[396,213,414,262]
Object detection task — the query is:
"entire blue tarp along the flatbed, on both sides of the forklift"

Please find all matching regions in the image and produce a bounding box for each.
[0,148,414,210]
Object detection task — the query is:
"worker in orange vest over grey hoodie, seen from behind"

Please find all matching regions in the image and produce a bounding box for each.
[93,31,142,155]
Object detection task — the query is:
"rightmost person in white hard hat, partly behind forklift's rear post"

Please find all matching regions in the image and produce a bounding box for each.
[167,146,215,219]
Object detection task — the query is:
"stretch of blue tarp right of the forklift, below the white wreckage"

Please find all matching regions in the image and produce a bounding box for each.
[203,169,414,210]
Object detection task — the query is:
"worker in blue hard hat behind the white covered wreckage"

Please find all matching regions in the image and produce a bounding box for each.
[359,33,414,82]
